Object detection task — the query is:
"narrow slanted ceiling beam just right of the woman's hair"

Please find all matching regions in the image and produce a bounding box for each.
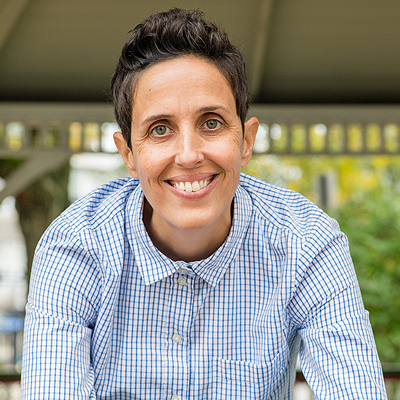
[249,0,273,101]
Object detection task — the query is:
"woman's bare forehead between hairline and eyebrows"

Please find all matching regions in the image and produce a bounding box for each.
[132,56,236,119]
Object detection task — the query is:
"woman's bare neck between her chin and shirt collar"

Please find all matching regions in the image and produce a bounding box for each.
[143,201,233,262]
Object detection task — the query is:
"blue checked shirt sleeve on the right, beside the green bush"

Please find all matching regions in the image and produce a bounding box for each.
[293,227,387,400]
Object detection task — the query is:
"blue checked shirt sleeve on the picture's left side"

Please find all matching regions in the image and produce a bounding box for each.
[21,220,101,400]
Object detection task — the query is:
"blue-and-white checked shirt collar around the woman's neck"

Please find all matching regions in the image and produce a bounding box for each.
[125,181,252,287]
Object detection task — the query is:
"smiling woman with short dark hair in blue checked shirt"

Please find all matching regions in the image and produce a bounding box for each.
[22,9,386,400]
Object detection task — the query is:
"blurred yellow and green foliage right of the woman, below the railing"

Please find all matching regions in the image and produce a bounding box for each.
[244,155,400,363]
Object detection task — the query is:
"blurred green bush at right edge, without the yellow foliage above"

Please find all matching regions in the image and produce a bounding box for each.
[336,187,400,363]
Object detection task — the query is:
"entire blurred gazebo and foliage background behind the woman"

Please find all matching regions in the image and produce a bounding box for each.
[0,0,400,400]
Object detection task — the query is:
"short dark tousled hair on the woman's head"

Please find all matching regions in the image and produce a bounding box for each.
[111,8,250,147]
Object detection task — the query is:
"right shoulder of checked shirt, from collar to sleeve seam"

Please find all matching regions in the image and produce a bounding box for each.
[239,173,340,238]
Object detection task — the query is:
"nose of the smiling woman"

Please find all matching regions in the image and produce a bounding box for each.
[175,130,204,168]
